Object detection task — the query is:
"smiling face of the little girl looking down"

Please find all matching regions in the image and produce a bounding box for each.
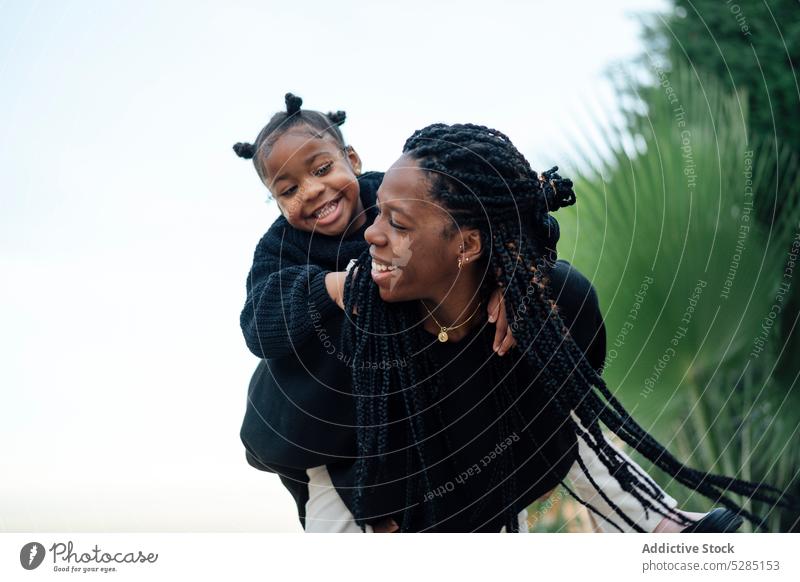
[262,127,366,236]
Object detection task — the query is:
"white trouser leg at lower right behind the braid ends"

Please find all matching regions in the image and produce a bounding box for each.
[567,412,678,532]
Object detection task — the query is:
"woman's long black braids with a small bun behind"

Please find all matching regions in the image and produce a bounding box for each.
[345,124,796,532]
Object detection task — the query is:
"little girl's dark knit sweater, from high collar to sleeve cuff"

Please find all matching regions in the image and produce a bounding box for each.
[239,172,383,358]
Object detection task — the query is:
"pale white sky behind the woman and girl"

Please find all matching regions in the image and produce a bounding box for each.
[0,0,665,531]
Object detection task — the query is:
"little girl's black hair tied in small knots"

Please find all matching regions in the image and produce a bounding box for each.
[228,93,347,181]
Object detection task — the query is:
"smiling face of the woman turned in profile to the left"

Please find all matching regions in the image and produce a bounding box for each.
[364,156,461,302]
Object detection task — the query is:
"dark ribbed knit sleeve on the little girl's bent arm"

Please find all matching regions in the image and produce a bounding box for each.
[239,233,339,358]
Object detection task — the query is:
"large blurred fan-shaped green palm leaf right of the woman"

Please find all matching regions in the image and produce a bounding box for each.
[559,60,800,420]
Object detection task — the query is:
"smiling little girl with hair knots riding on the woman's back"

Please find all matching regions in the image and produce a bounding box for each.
[233,93,376,358]
